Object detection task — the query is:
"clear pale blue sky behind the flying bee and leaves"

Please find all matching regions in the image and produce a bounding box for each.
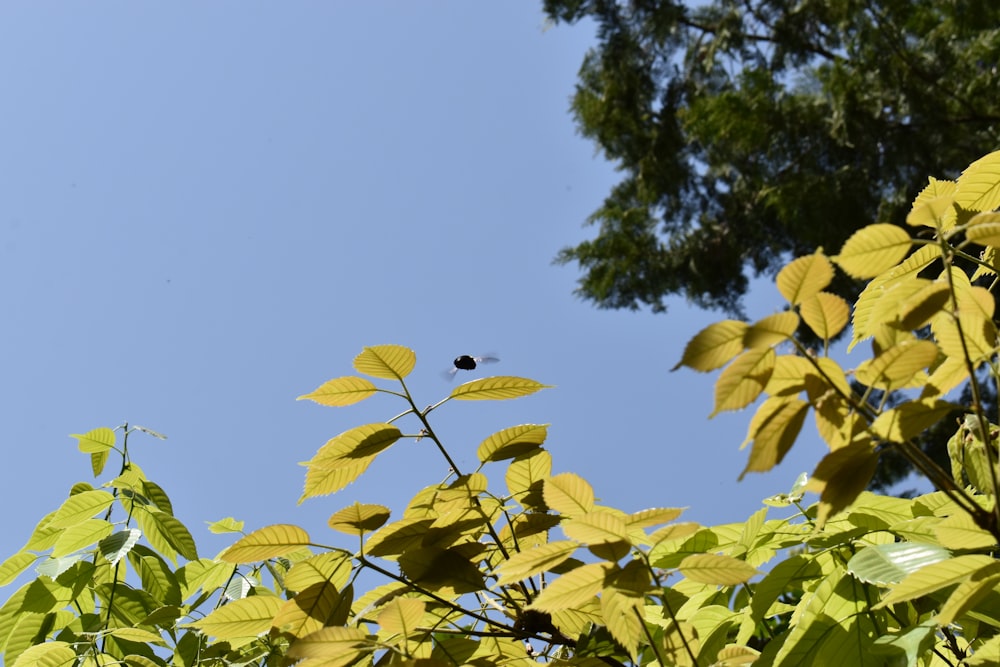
[0,0,823,559]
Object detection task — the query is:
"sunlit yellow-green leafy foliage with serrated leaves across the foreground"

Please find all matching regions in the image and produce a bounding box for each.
[13,152,1000,667]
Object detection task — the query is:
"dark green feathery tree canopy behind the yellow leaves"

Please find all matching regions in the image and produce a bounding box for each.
[544,0,1000,313]
